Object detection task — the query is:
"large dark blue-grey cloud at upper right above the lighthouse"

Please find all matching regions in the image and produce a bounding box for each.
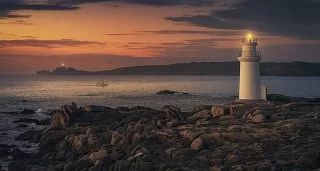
[166,0,320,39]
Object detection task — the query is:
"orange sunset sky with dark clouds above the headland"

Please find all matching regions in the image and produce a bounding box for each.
[0,0,320,73]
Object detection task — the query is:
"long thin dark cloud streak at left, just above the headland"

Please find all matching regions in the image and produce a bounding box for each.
[0,39,105,48]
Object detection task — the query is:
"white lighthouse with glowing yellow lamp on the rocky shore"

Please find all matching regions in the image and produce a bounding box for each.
[238,33,266,102]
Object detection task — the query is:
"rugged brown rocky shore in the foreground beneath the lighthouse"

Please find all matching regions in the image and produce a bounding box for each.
[0,95,320,171]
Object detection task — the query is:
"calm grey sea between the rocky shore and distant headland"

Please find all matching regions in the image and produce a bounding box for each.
[0,75,320,170]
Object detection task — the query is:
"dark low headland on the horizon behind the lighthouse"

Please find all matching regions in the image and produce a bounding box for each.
[37,61,320,76]
